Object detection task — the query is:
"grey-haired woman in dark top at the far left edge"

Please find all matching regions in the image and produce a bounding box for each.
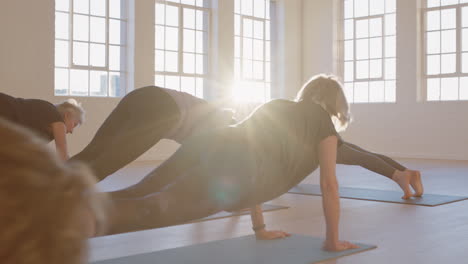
[0,93,84,160]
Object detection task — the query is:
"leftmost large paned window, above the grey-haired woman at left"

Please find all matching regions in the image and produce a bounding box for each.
[55,0,127,97]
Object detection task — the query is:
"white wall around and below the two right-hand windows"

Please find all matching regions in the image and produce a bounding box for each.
[303,0,468,160]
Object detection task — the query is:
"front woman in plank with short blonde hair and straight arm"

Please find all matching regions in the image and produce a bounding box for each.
[103,75,356,251]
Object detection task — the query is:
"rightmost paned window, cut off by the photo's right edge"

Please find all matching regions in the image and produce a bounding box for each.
[424,0,468,101]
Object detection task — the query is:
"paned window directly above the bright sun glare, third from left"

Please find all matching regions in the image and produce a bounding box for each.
[233,0,271,102]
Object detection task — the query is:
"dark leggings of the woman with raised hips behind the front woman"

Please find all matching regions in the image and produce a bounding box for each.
[70,86,180,180]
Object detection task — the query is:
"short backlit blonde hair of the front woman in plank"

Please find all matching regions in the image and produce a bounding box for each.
[295,74,351,131]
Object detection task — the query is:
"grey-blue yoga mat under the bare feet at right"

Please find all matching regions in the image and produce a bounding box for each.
[288,184,468,206]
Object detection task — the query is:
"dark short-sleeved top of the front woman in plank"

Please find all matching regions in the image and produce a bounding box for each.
[182,100,337,209]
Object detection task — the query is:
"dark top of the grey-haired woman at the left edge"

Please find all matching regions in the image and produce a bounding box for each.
[0,93,64,142]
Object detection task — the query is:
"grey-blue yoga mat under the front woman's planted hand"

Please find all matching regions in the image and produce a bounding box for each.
[94,235,376,264]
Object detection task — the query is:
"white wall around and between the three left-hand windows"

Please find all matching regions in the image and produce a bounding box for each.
[0,0,302,160]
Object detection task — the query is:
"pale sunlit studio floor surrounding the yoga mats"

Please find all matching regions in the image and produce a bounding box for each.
[90,159,468,264]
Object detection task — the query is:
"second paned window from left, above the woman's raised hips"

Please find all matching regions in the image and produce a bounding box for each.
[155,0,210,98]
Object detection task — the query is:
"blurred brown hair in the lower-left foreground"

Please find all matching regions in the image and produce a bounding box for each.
[0,118,106,264]
